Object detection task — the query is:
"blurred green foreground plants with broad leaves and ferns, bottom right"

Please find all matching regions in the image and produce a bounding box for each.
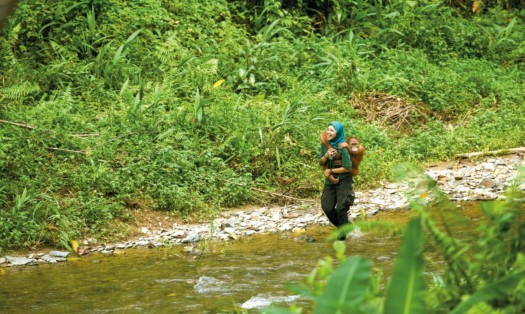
[261,164,525,314]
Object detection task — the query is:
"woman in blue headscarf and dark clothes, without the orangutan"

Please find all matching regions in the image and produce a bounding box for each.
[319,121,355,240]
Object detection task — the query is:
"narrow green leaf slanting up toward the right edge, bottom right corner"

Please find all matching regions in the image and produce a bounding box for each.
[451,271,525,314]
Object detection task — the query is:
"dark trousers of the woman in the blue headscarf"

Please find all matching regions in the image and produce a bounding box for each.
[321,176,354,227]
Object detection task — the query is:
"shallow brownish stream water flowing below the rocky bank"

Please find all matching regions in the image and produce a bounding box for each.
[0,202,479,313]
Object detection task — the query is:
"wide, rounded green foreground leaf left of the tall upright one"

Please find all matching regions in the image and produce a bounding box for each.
[314,256,372,314]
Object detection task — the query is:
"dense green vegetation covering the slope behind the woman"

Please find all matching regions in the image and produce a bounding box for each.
[0,0,525,250]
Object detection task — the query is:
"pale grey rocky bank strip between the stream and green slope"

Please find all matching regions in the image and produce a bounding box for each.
[0,154,525,267]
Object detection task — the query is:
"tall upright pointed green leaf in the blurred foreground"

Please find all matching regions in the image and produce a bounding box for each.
[384,219,426,314]
